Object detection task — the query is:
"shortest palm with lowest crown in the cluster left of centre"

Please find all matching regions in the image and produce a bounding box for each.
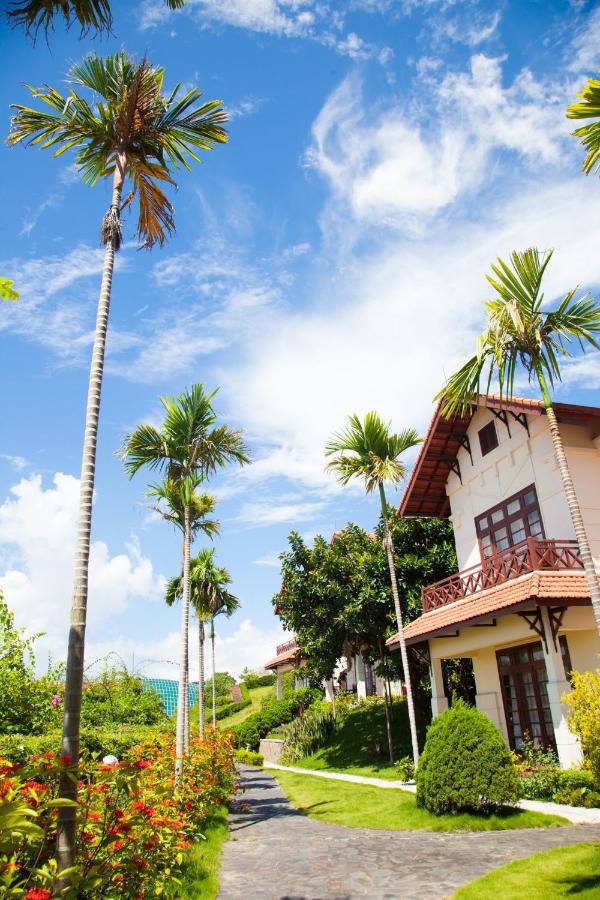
[166,548,239,737]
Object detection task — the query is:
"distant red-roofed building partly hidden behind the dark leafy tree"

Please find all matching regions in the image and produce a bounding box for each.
[263,638,403,700]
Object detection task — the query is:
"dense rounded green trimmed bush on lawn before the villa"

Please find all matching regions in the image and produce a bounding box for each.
[417,700,519,815]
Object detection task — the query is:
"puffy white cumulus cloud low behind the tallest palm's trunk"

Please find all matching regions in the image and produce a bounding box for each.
[0,472,164,663]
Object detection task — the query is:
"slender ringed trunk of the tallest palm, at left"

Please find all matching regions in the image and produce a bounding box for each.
[56,171,124,887]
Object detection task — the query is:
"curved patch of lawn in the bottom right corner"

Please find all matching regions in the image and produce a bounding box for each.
[453,844,600,900]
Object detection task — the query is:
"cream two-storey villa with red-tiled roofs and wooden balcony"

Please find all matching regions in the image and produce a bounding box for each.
[388,397,600,767]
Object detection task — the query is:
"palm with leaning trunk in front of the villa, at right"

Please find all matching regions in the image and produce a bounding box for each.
[436,247,600,633]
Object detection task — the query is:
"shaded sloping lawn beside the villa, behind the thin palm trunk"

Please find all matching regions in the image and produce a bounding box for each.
[294,700,418,780]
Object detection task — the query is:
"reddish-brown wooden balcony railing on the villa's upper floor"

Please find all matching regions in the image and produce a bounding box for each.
[421,538,583,612]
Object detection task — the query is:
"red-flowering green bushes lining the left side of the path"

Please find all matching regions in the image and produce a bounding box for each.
[0,732,236,900]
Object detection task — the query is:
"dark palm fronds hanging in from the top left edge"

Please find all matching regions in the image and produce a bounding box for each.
[7,0,185,38]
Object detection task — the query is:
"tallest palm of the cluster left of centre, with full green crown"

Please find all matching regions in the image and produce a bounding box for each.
[119,384,249,777]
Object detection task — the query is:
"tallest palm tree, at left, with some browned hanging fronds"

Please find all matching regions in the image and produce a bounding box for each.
[8,52,227,871]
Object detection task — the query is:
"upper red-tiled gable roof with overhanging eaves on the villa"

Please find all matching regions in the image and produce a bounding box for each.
[398,395,600,519]
